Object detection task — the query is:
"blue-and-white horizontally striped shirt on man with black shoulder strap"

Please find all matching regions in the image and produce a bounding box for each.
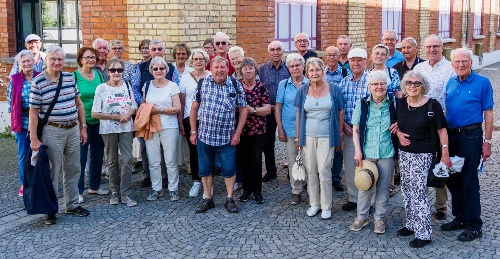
[30,72,80,123]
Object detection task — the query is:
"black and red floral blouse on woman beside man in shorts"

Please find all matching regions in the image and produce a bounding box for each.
[241,81,269,136]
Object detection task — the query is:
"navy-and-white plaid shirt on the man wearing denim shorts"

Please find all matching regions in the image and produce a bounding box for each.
[193,75,247,146]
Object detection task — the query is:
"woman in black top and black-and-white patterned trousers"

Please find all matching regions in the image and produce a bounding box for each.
[397,70,451,248]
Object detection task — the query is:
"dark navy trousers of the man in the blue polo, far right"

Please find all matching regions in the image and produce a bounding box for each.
[447,128,483,230]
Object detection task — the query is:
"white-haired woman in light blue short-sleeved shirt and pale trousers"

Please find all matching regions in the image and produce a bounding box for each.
[275,53,309,205]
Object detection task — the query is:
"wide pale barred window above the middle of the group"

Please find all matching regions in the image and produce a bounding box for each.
[274,0,318,51]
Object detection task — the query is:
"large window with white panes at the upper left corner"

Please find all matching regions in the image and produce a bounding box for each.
[15,0,82,54]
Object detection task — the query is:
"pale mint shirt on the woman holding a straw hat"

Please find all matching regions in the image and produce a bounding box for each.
[352,96,394,159]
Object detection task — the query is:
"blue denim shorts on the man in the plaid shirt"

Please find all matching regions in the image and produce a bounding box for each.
[197,139,236,178]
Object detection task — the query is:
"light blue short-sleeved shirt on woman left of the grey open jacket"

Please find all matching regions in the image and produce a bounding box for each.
[276,76,309,138]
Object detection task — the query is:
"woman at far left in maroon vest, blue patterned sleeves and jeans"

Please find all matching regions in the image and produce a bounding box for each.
[7,50,40,196]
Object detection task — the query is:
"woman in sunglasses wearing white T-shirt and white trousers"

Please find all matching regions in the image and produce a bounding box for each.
[142,57,181,201]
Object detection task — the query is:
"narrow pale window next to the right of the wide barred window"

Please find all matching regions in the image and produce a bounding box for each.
[380,0,403,41]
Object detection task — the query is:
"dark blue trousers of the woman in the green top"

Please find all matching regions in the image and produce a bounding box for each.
[78,123,104,194]
